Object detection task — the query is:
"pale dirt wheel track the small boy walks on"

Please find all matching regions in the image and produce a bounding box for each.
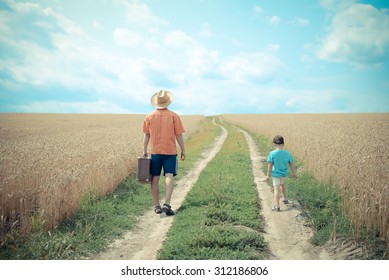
[237,128,331,260]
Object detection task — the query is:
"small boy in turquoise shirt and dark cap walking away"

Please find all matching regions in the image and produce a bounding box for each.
[266,135,297,212]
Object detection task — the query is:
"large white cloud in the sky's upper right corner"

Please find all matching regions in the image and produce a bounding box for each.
[317,4,389,66]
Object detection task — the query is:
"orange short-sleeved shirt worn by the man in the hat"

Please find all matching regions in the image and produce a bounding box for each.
[143,109,185,155]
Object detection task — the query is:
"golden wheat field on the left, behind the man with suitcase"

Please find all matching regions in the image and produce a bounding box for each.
[0,114,203,239]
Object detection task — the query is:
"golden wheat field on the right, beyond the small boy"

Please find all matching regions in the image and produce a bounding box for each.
[223,114,389,243]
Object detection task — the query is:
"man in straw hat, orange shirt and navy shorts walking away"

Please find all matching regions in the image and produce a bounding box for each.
[143,90,186,216]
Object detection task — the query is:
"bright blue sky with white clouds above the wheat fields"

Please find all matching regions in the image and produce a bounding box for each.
[0,0,389,115]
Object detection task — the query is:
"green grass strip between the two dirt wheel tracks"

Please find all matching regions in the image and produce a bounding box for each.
[158,120,268,260]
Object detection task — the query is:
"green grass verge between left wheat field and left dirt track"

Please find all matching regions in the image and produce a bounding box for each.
[0,118,220,260]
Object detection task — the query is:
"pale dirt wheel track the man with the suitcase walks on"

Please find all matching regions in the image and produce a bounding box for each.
[94,119,228,260]
